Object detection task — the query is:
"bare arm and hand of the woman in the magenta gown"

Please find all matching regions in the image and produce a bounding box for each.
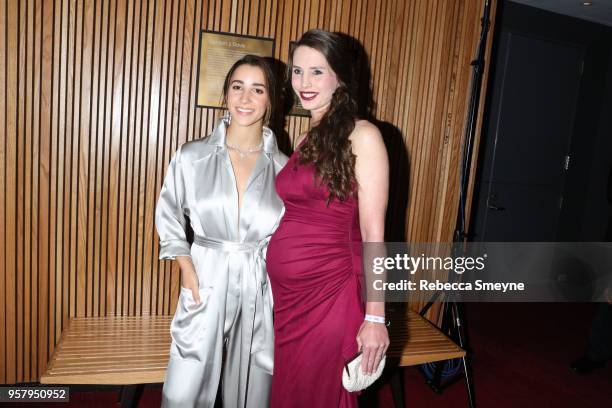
[350,121,389,373]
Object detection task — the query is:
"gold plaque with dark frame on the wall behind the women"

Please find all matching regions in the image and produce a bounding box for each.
[196,30,274,108]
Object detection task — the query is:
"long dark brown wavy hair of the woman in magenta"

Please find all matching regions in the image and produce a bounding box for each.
[287,29,357,204]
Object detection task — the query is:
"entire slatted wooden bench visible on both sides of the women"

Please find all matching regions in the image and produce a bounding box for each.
[40,311,465,407]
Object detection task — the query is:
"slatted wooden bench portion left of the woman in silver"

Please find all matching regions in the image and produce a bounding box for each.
[40,316,172,406]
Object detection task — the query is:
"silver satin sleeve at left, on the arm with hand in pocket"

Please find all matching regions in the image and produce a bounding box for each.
[155,148,191,259]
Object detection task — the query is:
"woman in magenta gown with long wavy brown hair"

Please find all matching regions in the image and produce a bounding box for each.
[266,30,389,408]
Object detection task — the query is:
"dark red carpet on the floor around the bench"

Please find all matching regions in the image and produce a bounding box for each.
[5,303,612,408]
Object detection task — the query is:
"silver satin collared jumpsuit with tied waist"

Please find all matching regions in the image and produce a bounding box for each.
[155,118,287,408]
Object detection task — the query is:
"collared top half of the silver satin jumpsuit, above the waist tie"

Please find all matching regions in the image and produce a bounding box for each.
[155,118,287,259]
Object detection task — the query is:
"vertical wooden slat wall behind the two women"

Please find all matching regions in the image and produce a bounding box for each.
[0,0,494,383]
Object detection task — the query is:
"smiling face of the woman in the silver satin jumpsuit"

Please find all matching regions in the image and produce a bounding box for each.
[226,64,270,126]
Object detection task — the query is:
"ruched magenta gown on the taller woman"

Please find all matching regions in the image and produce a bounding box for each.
[266,152,364,408]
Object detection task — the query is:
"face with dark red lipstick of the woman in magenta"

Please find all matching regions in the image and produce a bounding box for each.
[291,45,339,118]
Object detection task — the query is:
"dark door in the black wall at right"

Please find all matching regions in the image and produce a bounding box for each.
[473,32,584,242]
